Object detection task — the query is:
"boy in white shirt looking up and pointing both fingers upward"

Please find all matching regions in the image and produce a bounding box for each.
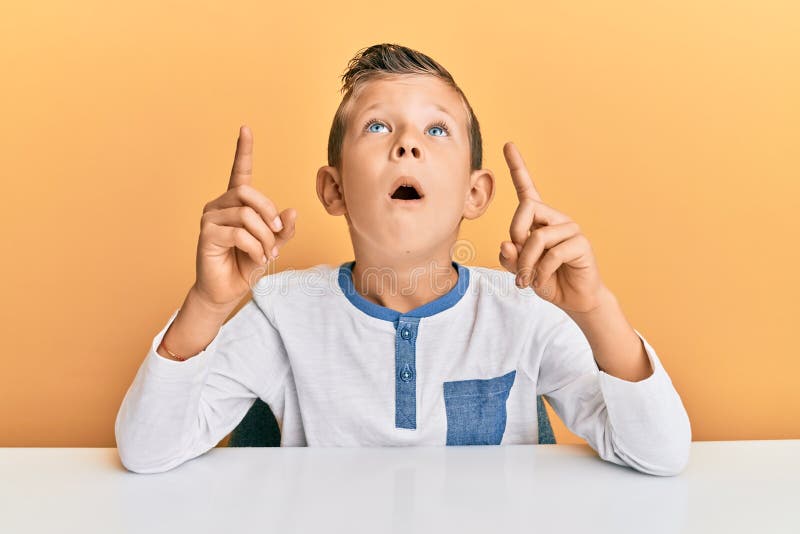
[115,44,691,475]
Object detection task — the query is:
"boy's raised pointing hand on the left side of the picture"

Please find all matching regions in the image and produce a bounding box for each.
[192,126,297,310]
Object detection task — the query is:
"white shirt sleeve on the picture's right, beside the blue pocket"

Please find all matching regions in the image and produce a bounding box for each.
[537,314,692,476]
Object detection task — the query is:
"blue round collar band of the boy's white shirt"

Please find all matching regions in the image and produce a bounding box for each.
[339,260,469,324]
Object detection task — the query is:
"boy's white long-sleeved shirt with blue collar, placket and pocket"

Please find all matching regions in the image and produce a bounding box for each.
[115,261,691,475]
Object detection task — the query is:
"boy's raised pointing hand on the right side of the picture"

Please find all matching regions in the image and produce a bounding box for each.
[500,142,608,312]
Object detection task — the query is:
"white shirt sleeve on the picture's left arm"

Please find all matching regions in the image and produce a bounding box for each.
[114,300,288,473]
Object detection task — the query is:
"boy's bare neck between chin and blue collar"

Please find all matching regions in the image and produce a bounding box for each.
[353,253,458,313]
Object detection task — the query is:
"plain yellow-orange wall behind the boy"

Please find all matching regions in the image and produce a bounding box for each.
[0,0,800,446]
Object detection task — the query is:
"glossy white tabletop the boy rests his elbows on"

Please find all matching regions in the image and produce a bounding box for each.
[0,440,800,534]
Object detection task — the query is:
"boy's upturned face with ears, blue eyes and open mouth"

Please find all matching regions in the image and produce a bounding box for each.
[317,75,494,259]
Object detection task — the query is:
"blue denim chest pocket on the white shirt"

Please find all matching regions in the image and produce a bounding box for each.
[444,370,517,445]
